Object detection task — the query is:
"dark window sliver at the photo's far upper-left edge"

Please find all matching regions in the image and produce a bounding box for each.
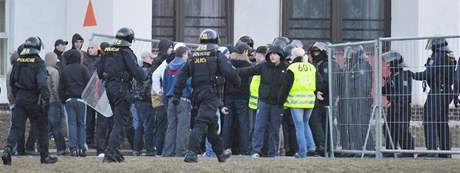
[0,0,9,75]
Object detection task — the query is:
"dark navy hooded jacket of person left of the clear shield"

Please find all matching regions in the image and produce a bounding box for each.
[59,49,90,102]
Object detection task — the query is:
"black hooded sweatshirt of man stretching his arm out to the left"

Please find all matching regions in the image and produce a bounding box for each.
[237,47,287,105]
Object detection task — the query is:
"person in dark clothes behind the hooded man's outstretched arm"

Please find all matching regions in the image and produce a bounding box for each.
[222,42,251,155]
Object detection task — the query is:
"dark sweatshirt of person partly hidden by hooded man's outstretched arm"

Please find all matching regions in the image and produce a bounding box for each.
[224,52,251,100]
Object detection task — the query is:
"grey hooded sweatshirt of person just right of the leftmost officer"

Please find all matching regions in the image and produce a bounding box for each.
[45,52,60,103]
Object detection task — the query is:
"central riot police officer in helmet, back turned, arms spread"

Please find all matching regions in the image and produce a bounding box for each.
[172,29,241,162]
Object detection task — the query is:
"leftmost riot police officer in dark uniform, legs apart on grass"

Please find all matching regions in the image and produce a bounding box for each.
[2,37,57,165]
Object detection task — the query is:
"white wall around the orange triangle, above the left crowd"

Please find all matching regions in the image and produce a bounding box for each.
[0,0,152,103]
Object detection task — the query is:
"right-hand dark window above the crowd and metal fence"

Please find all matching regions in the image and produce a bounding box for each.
[282,0,391,46]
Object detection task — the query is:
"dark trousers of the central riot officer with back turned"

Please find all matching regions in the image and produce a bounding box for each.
[189,88,223,155]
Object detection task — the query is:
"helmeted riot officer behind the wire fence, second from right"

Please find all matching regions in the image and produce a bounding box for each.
[382,51,414,157]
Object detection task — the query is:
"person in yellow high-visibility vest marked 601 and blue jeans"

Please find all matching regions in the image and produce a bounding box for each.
[279,48,316,158]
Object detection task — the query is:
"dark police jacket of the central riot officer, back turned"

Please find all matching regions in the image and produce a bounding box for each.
[174,44,241,98]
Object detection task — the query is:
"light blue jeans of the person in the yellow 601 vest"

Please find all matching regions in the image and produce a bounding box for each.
[291,108,316,157]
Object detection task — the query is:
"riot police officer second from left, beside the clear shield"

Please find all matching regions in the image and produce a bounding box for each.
[97,28,146,162]
